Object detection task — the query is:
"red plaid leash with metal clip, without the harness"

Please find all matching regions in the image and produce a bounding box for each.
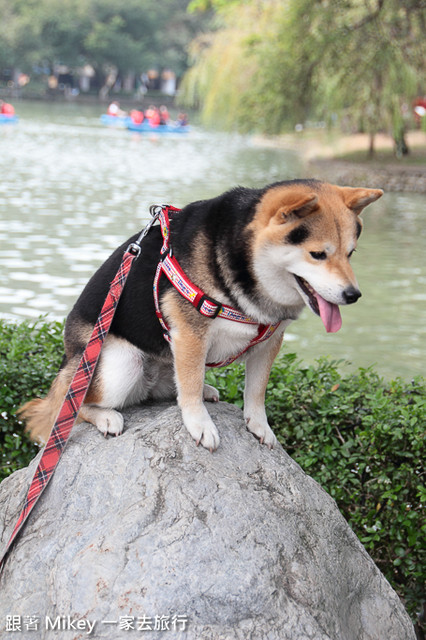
[0,215,158,572]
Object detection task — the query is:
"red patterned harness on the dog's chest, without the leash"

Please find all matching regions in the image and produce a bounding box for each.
[151,205,280,367]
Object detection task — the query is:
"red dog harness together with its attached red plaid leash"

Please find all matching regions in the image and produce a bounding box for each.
[0,205,280,572]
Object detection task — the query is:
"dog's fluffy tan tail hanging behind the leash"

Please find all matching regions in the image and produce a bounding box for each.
[16,366,72,444]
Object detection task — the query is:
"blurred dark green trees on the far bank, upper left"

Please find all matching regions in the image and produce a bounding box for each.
[0,0,206,75]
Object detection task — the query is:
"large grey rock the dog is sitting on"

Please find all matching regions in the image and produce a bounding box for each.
[0,403,415,640]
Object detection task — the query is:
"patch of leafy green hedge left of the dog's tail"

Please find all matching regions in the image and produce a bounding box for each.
[0,320,63,480]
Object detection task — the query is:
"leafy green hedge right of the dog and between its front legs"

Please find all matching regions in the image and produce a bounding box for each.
[207,355,426,616]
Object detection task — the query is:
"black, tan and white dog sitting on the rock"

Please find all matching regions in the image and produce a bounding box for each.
[19,179,383,451]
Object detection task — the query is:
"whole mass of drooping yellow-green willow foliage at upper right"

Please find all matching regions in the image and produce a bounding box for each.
[184,0,426,153]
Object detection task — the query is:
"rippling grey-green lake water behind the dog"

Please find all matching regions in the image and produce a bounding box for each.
[0,102,426,379]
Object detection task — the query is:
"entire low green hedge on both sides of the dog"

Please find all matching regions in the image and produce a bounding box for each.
[0,320,426,617]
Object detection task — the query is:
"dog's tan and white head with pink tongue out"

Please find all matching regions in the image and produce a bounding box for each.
[250,180,383,332]
